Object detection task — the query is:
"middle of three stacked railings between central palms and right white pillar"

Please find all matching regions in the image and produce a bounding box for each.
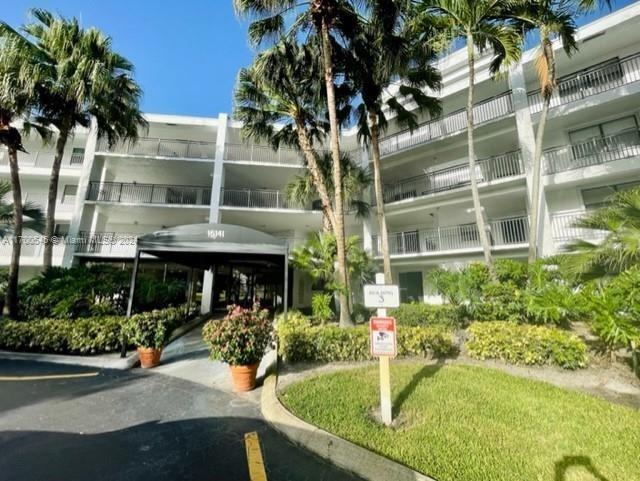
[384,150,524,203]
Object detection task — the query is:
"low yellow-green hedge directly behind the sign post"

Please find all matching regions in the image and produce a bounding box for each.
[276,312,455,362]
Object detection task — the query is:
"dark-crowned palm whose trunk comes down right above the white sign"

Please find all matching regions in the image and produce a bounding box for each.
[347,0,441,284]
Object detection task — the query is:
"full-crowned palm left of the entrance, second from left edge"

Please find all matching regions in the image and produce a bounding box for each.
[0,9,146,270]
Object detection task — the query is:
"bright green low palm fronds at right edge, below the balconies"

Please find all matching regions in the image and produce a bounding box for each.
[562,187,640,279]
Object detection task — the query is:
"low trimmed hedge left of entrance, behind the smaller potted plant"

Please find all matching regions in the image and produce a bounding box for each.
[0,307,194,354]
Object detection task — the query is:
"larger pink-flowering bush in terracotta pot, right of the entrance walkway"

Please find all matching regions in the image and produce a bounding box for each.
[202,304,272,391]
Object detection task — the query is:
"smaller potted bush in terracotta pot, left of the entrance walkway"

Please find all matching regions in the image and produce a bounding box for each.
[124,312,169,369]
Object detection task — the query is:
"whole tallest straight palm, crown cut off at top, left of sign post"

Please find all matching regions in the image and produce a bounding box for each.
[233,0,358,325]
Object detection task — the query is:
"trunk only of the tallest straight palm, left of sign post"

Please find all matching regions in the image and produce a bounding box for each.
[320,18,353,327]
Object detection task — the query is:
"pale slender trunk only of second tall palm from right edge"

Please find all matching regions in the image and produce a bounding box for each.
[467,32,493,275]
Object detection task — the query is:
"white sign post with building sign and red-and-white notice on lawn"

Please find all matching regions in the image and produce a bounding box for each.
[364,274,400,426]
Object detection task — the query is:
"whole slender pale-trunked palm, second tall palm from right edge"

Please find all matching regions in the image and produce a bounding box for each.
[415,0,522,275]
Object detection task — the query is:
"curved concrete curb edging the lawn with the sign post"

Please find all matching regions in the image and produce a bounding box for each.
[260,355,435,481]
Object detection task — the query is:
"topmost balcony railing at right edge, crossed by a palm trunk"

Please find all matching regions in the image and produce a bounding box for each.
[527,53,640,113]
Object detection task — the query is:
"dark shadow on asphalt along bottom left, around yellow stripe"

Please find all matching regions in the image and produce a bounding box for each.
[0,417,357,481]
